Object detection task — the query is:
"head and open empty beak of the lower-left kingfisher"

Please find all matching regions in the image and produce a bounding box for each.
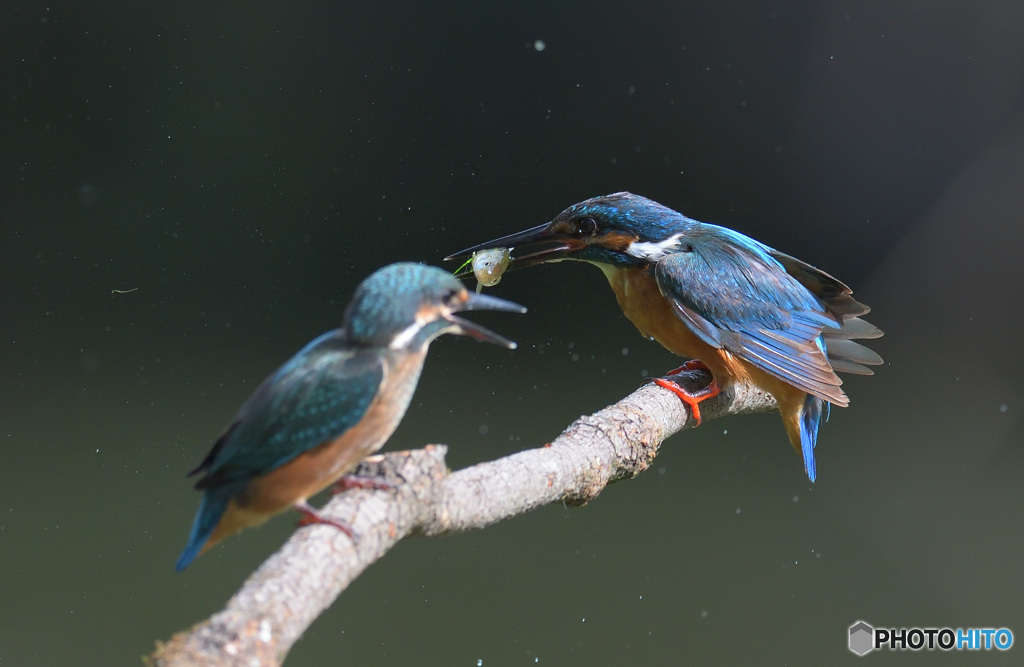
[342,262,526,349]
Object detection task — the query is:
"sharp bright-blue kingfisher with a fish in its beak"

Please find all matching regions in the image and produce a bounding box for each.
[446,193,882,482]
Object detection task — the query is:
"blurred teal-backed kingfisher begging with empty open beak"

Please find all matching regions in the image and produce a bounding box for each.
[176,263,526,571]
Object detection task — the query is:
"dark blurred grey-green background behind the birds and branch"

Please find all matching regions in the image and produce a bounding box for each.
[0,0,1024,665]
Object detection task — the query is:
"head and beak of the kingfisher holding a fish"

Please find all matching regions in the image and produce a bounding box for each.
[445,193,692,269]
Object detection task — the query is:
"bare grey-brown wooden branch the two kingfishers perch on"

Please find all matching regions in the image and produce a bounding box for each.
[147,371,775,667]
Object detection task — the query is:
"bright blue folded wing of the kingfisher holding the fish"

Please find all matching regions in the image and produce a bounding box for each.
[654,224,849,406]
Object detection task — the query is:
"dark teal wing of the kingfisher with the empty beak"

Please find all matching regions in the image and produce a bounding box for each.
[189,330,386,489]
